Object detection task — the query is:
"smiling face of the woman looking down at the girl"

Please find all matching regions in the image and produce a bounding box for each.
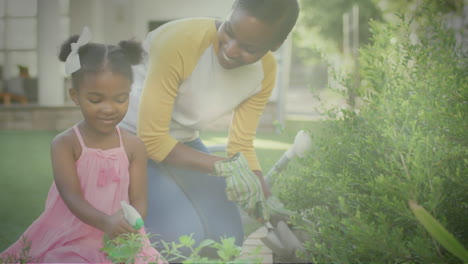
[217,9,281,69]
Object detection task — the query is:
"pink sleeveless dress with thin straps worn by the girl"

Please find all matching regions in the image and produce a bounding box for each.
[0,125,163,263]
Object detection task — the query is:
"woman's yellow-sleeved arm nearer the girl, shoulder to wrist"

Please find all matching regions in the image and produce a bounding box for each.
[137,20,222,172]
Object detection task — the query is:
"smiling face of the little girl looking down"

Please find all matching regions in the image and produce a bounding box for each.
[70,71,131,134]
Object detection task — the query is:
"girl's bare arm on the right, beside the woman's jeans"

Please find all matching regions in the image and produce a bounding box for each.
[126,133,148,219]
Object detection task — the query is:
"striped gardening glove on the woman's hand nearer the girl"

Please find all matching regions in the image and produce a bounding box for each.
[214,152,269,221]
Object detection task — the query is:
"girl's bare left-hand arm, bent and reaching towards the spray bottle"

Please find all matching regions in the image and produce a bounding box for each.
[51,133,137,238]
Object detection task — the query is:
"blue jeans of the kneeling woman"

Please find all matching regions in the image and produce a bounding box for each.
[145,139,244,255]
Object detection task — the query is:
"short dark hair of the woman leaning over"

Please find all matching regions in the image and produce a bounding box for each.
[233,0,299,43]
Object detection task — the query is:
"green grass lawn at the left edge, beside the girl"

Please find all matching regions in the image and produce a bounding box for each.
[0,131,56,251]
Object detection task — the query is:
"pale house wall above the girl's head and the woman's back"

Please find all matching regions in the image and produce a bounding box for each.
[70,0,234,43]
